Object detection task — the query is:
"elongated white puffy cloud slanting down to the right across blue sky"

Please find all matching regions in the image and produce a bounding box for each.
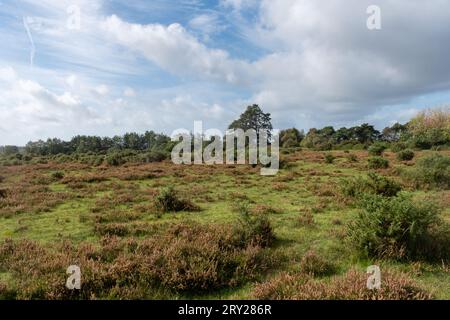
[103,15,248,84]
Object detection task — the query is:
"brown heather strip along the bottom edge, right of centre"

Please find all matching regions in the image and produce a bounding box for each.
[253,269,433,300]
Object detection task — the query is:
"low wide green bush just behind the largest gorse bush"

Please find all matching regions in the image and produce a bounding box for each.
[341,172,402,198]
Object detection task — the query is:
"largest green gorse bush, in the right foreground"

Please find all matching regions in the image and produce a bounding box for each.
[348,195,441,259]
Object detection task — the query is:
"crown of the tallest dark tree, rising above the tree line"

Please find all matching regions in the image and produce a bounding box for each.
[228,104,273,138]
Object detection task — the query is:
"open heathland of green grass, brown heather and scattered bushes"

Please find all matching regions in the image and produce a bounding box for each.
[0,106,450,299]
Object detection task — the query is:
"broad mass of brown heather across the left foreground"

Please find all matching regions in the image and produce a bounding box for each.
[0,219,277,299]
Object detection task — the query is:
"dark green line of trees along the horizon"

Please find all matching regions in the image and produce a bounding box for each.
[0,104,450,156]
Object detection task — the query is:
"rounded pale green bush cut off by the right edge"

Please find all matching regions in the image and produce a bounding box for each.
[404,153,450,189]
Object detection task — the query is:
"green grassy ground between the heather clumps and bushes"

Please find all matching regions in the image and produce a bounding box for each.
[0,151,450,299]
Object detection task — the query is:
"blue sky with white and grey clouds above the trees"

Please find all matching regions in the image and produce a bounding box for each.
[0,0,450,145]
